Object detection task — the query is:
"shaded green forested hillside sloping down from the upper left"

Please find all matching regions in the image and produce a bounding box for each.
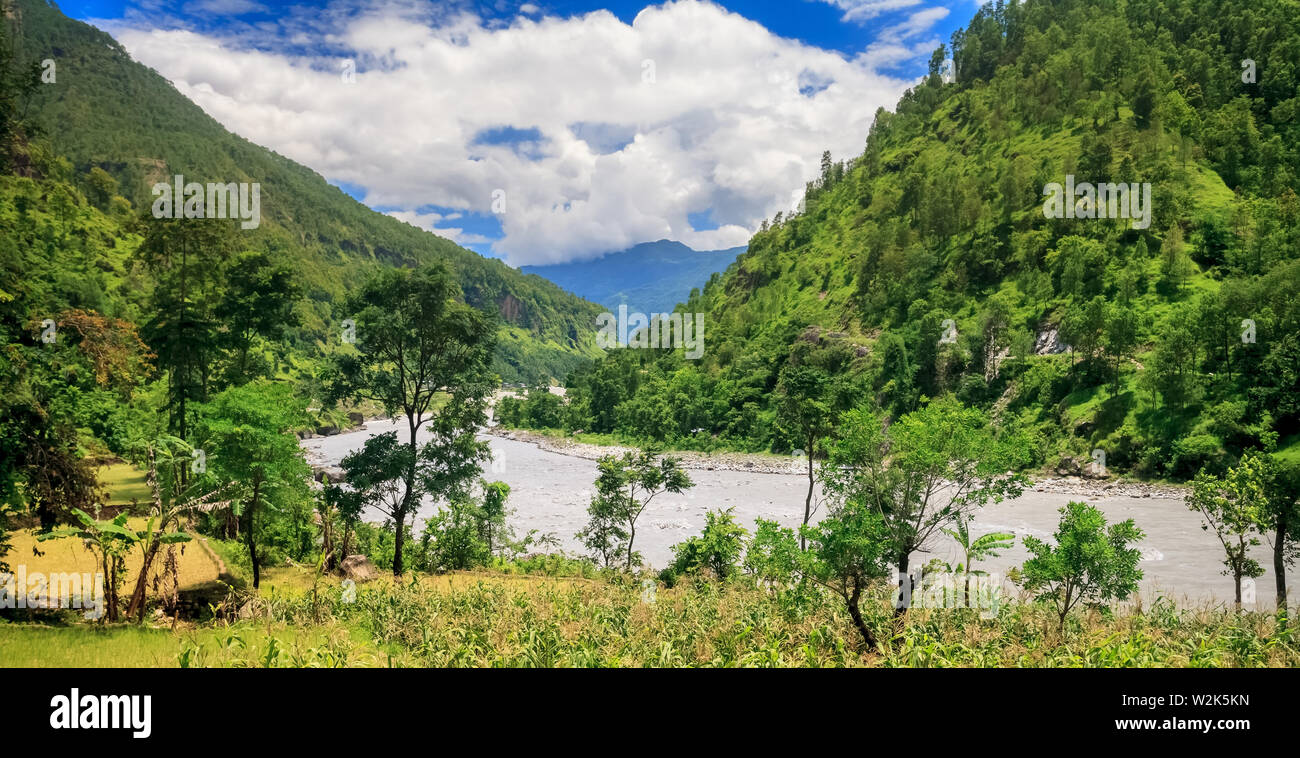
[10,0,599,381]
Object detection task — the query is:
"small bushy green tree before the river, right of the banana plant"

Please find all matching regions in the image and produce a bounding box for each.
[1022,502,1144,631]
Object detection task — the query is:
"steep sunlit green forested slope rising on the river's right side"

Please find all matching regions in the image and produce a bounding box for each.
[559,0,1300,477]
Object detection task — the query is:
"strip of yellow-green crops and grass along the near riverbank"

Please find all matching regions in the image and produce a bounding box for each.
[0,568,1300,667]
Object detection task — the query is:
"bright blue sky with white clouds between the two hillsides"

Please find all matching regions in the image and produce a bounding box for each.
[76,0,978,265]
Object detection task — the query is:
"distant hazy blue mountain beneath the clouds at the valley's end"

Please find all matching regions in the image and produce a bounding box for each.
[520,239,745,313]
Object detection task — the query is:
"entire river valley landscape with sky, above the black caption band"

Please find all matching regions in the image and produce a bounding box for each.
[0,0,1300,681]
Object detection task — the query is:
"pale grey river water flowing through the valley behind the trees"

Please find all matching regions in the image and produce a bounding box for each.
[302,420,1297,608]
